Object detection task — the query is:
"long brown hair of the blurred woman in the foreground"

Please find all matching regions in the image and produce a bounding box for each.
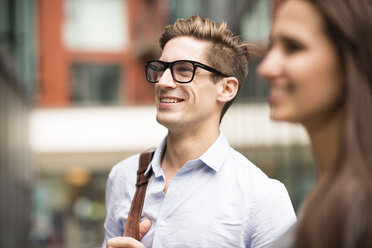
[294,0,372,248]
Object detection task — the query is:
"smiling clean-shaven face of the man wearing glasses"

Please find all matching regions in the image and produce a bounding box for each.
[155,37,221,132]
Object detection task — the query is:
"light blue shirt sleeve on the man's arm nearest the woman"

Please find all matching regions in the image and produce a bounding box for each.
[251,180,297,248]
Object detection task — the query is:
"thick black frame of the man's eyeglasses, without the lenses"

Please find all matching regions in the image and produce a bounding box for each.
[145,59,230,84]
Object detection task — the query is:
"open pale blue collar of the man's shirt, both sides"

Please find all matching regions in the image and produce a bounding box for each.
[145,132,231,174]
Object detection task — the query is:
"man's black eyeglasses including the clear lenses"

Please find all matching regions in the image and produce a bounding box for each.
[145,60,229,84]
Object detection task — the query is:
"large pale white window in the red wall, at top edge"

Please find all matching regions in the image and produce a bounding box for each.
[63,0,129,52]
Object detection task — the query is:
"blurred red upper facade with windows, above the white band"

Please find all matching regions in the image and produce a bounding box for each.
[38,0,169,107]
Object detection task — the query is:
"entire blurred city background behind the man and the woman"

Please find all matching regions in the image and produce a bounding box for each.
[0,0,315,248]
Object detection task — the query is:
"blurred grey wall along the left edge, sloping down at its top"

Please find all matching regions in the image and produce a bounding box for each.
[0,53,33,247]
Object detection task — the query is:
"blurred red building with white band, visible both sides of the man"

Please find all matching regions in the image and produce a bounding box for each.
[26,0,313,247]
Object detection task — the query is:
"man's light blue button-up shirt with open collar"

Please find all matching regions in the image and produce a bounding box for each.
[102,133,296,248]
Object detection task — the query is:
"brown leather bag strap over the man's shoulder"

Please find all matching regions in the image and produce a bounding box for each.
[124,149,155,241]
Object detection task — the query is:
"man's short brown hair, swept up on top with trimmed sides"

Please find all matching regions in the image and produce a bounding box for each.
[159,15,250,119]
